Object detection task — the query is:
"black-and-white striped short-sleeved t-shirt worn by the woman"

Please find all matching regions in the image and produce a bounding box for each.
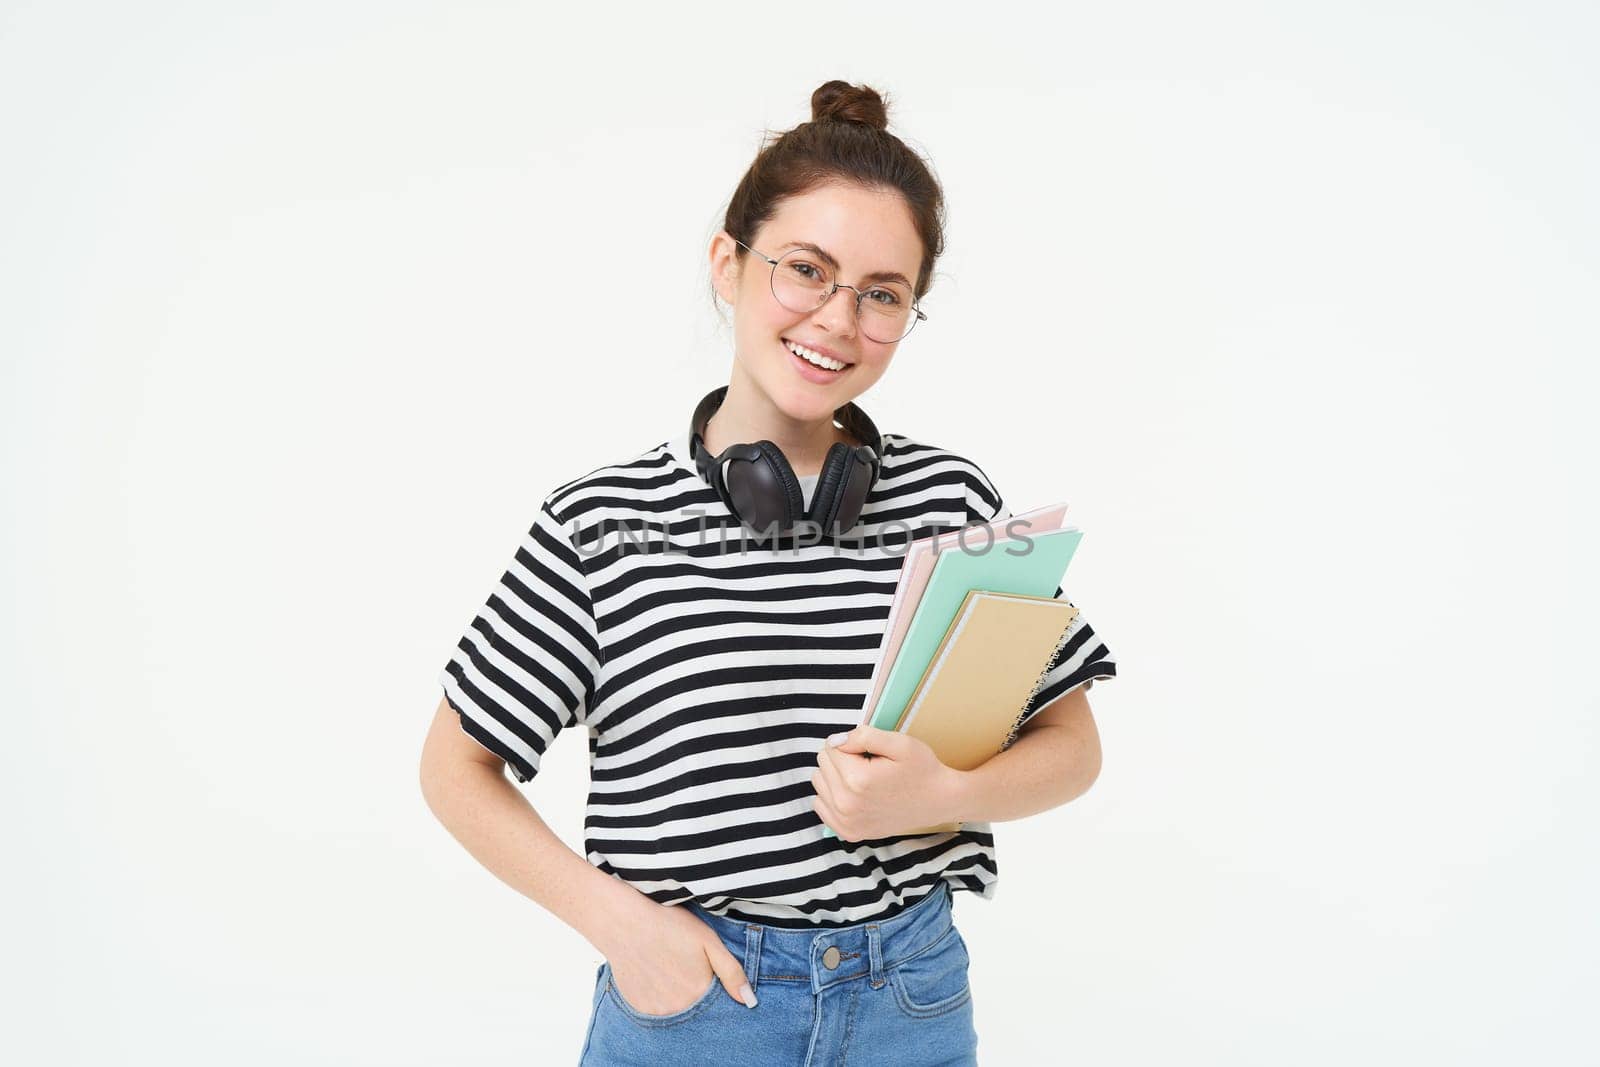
[438,430,1117,928]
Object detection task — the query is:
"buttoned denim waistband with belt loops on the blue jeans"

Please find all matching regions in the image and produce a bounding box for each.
[685,878,954,993]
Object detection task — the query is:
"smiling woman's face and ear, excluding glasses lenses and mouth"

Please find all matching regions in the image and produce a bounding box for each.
[712,184,922,421]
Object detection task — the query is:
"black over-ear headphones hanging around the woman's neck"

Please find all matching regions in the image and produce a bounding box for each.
[690,386,883,537]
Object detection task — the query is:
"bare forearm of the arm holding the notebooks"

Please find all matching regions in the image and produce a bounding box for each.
[946,723,1099,822]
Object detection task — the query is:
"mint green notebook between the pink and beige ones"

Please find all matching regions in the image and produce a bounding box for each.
[872,530,1083,729]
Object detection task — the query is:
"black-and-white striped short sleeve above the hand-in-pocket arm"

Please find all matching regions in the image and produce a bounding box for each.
[438,498,600,782]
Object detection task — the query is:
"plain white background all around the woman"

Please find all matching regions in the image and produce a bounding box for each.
[0,3,1600,1065]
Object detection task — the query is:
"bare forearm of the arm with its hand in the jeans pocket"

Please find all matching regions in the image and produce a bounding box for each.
[422,763,654,957]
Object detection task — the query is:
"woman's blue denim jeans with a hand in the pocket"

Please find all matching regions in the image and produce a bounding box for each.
[579,881,978,1067]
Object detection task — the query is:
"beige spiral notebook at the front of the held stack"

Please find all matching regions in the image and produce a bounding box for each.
[896,589,1078,833]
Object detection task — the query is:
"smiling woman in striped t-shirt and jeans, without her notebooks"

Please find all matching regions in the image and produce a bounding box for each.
[422,82,1117,1067]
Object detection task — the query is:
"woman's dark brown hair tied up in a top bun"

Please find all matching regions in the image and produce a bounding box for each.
[722,80,944,299]
